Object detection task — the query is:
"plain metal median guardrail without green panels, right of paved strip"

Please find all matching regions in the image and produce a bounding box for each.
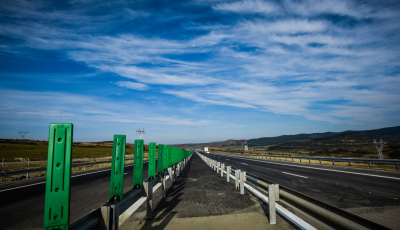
[200,152,390,229]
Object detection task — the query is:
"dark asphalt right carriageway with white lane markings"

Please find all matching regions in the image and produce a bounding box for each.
[205,154,400,229]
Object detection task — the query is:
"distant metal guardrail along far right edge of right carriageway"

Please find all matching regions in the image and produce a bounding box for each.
[222,153,400,170]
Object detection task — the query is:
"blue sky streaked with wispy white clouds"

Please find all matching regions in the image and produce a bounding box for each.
[0,0,400,144]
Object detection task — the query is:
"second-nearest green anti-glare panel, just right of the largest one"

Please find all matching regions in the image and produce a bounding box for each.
[110,135,126,201]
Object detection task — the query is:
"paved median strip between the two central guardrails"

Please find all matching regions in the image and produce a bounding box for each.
[122,154,293,229]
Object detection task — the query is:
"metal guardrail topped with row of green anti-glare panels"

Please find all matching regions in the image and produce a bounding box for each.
[43,123,193,230]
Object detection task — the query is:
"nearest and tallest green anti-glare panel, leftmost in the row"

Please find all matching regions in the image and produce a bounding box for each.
[43,123,73,230]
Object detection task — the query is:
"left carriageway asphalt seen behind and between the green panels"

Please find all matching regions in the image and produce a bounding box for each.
[0,162,148,230]
